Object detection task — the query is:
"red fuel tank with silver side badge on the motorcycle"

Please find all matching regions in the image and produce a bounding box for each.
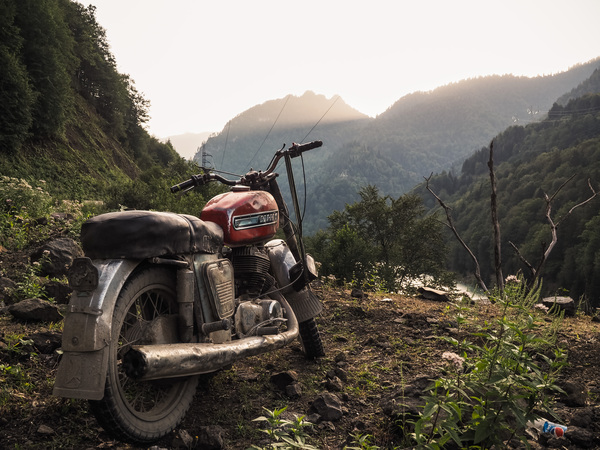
[200,186,279,247]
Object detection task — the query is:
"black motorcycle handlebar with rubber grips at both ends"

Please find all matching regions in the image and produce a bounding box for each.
[171,141,323,194]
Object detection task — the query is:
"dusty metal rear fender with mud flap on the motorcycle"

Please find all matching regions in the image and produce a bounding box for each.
[53,259,140,400]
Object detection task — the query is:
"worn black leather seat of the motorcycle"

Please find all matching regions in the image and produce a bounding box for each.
[81,210,223,259]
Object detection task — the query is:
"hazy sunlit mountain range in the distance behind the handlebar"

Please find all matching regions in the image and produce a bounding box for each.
[195,59,600,231]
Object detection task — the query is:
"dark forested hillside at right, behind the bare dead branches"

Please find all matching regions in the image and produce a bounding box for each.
[417,87,600,306]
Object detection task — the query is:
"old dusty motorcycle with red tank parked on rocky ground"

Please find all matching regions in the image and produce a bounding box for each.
[54,141,324,444]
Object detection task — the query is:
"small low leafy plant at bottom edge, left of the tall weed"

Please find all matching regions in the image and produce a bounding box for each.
[250,406,317,450]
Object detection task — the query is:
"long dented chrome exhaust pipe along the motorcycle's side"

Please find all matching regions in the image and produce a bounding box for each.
[123,294,299,381]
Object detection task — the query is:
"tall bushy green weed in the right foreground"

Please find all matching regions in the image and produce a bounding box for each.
[412,278,566,449]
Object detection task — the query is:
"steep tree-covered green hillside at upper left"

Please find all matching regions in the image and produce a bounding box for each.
[0,0,204,213]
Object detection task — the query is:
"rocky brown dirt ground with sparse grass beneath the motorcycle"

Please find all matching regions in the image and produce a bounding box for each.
[0,244,600,449]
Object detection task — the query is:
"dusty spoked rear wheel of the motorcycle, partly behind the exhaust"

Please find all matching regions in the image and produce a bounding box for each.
[90,267,198,444]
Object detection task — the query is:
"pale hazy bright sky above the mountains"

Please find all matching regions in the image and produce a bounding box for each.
[85,0,600,137]
